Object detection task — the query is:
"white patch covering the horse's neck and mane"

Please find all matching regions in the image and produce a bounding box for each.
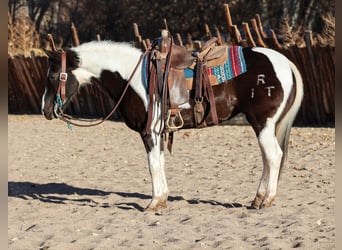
[71,41,148,109]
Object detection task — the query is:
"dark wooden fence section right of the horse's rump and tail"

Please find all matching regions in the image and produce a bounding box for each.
[279,46,335,125]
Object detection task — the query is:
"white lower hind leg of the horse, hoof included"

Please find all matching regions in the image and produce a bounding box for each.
[252,121,283,208]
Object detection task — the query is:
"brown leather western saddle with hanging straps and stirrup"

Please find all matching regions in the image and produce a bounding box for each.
[146,30,228,151]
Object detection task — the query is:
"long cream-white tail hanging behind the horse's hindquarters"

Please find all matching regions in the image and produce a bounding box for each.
[276,61,304,169]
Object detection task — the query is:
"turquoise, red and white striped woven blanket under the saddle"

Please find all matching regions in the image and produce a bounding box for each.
[184,46,247,85]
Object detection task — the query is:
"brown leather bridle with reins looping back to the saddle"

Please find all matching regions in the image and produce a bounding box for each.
[54,50,147,128]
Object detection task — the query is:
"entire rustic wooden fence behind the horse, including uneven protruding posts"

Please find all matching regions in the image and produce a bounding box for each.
[8,4,335,126]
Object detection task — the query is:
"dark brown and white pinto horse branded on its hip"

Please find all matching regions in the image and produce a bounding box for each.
[42,41,303,211]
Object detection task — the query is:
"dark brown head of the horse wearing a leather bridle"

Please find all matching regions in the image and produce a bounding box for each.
[42,49,79,120]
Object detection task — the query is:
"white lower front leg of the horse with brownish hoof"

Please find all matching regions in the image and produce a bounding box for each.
[141,132,169,211]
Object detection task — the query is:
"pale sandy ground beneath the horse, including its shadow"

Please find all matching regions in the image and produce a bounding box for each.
[8,115,335,250]
